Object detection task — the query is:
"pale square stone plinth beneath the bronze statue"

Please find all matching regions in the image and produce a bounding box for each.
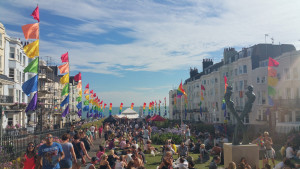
[223,143,259,168]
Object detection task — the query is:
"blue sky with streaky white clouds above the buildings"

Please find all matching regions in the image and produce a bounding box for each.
[0,0,300,106]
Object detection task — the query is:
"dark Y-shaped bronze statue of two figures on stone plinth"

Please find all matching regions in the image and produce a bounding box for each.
[224,86,255,145]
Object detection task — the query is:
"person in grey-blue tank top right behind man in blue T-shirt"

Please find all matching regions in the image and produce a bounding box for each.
[59,133,77,169]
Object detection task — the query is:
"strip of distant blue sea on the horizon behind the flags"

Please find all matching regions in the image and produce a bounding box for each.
[82,106,169,119]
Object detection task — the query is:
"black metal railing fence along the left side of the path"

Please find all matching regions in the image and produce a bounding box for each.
[0,127,68,164]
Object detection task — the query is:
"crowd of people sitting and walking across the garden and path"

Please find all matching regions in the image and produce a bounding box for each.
[21,121,300,169]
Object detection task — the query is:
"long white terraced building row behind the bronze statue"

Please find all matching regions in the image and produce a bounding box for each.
[169,44,300,132]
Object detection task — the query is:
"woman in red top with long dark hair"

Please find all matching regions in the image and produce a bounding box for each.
[20,142,37,169]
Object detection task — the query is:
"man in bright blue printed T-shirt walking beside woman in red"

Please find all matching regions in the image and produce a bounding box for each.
[37,134,65,169]
